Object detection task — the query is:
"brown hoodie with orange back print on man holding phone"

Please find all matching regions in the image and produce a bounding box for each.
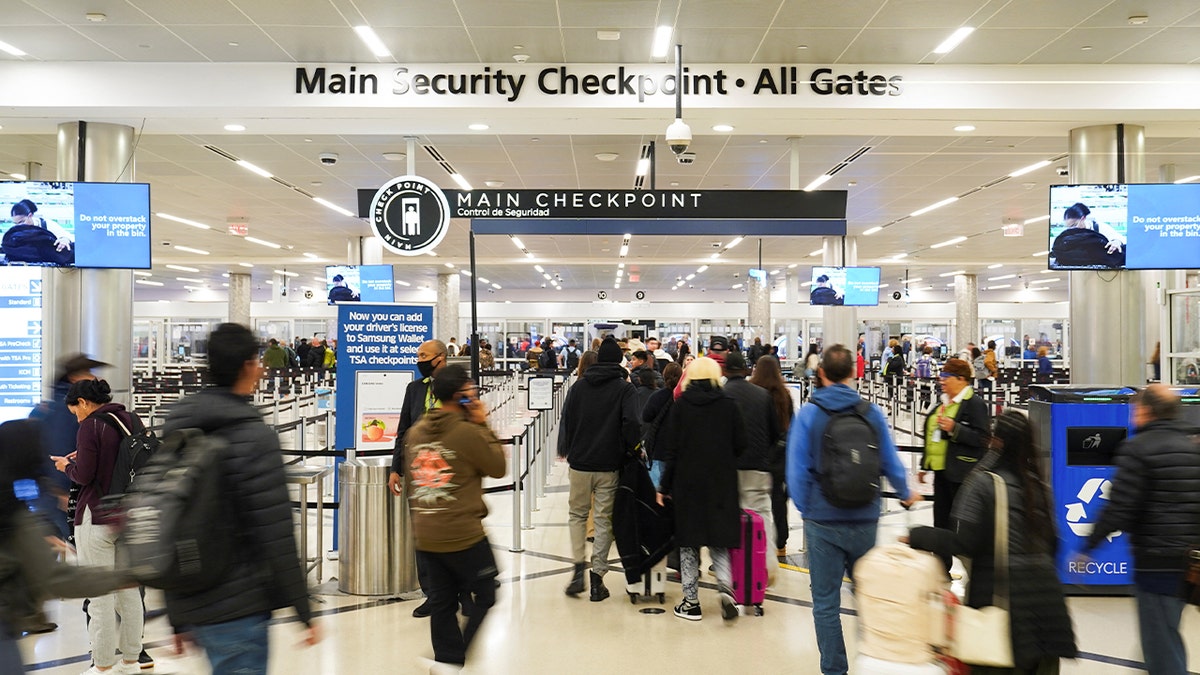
[404,408,505,554]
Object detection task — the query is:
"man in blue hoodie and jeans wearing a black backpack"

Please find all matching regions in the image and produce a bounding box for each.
[787,345,920,675]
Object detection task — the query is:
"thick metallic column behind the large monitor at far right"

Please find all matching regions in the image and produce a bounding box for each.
[1075,124,1157,386]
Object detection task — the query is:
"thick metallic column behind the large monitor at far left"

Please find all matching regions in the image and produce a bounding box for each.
[42,121,134,405]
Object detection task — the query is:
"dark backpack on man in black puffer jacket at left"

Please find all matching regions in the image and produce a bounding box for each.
[116,429,238,593]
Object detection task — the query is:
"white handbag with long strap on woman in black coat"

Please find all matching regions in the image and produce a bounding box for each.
[950,472,1015,668]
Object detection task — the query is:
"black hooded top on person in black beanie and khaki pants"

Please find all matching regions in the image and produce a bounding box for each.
[558,363,642,471]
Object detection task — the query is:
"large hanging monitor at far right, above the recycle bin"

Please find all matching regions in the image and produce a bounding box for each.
[1048,184,1200,270]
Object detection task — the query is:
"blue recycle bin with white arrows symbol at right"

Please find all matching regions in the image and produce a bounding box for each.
[1030,384,1136,595]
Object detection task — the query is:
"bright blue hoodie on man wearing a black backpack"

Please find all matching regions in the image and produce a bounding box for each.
[787,384,911,522]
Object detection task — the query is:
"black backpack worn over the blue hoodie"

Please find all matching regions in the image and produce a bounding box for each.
[809,401,882,508]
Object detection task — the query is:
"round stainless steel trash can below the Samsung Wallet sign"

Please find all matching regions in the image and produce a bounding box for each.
[337,458,418,596]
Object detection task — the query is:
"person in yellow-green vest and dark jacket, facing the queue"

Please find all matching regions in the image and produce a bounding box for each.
[917,358,991,528]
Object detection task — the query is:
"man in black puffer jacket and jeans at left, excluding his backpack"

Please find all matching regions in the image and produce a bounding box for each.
[163,323,319,674]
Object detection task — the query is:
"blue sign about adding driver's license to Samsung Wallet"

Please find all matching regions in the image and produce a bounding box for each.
[336,304,433,452]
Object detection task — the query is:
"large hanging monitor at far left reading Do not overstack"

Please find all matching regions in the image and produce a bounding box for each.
[0,181,150,269]
